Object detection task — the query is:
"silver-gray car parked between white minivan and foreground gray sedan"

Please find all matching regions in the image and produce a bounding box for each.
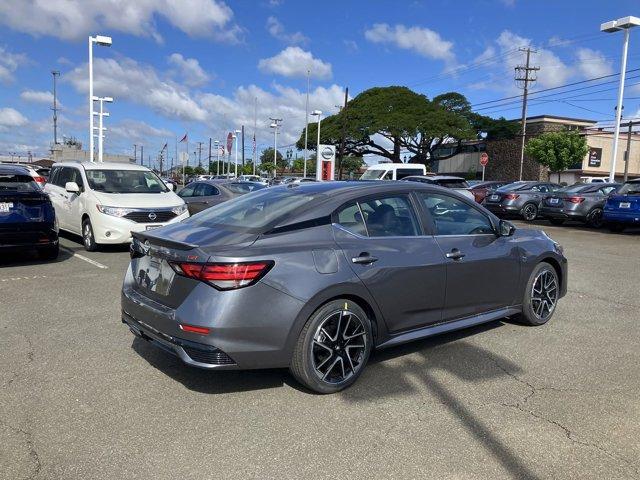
[178,180,266,215]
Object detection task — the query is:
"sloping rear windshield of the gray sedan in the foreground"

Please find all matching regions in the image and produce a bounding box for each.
[188,187,322,232]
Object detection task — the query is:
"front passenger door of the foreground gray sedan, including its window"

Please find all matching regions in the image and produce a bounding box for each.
[417,192,520,321]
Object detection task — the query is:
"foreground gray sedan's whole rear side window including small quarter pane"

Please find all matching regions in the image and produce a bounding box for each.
[337,196,419,237]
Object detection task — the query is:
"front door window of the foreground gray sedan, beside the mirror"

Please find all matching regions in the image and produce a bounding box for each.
[419,193,495,235]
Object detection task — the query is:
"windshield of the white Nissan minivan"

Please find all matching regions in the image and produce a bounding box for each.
[86,169,169,193]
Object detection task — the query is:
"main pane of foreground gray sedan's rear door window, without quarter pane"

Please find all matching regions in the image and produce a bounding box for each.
[359,196,419,237]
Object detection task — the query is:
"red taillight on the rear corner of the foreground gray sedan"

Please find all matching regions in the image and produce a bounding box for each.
[171,261,273,290]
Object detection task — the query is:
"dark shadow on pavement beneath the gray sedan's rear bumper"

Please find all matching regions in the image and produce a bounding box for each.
[131,338,291,395]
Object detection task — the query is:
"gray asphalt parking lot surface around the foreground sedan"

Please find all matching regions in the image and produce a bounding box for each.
[0,222,640,480]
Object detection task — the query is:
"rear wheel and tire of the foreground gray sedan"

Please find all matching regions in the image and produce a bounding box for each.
[290,299,373,394]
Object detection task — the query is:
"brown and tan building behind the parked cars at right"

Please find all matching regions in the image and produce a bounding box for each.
[432,115,640,184]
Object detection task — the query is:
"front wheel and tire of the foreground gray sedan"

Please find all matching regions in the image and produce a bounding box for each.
[518,262,560,326]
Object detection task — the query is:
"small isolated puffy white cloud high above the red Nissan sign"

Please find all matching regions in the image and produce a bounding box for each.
[258,47,333,79]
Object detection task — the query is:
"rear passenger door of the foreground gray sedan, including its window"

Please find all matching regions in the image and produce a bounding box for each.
[334,194,445,332]
